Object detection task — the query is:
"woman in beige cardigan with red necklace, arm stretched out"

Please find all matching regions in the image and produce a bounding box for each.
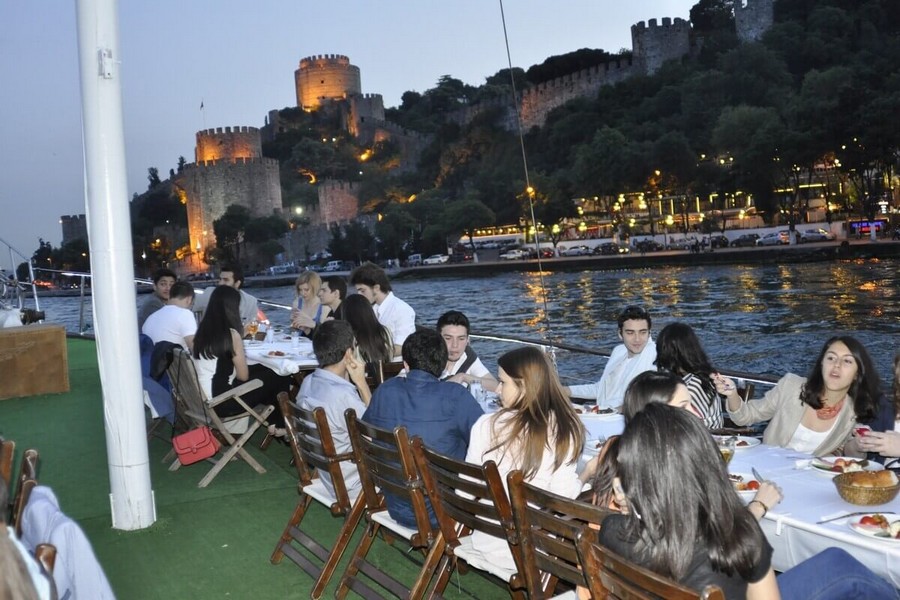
[714,336,880,456]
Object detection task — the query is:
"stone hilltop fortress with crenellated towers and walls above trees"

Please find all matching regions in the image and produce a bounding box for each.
[169,0,774,268]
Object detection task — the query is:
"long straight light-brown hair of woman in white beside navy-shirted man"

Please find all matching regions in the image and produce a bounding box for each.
[489,347,584,479]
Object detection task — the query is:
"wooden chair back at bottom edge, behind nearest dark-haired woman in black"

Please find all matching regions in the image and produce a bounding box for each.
[575,527,725,600]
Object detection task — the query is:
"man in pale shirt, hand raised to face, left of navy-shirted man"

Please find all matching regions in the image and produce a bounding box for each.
[297,321,372,498]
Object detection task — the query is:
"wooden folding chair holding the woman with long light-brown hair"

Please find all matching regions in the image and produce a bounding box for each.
[413,437,525,598]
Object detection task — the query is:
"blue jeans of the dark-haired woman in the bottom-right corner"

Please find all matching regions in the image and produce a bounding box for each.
[777,548,900,600]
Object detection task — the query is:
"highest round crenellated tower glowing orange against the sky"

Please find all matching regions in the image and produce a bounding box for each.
[294,54,362,110]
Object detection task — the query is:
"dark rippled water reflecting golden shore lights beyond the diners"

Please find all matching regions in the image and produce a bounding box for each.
[35,261,900,381]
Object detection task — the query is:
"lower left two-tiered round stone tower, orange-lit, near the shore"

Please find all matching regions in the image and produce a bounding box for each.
[175,127,281,253]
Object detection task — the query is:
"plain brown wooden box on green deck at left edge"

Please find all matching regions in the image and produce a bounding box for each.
[0,323,69,399]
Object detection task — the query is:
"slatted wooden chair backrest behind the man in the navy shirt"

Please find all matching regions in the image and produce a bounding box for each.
[344,409,433,547]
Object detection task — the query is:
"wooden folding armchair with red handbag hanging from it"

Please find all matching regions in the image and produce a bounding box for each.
[165,348,275,487]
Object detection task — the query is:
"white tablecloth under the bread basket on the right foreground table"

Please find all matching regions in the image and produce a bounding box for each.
[729,445,900,587]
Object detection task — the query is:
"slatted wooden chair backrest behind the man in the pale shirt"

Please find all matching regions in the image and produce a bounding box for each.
[278,392,353,516]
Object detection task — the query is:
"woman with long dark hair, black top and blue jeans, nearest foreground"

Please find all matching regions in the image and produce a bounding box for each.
[600,403,897,600]
